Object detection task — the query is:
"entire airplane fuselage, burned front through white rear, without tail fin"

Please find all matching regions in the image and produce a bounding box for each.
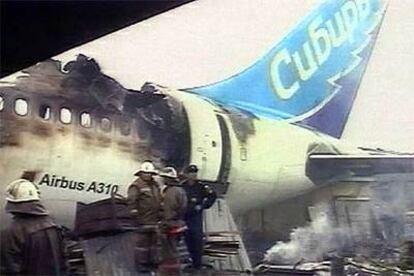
[0,55,337,225]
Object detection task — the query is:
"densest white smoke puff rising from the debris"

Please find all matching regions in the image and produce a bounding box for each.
[265,213,349,263]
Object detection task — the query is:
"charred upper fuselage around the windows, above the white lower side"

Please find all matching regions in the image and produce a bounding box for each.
[0,55,190,169]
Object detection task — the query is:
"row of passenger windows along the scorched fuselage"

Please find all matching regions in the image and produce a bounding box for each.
[0,95,131,135]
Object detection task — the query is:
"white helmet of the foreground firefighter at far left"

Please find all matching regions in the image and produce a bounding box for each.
[6,179,40,202]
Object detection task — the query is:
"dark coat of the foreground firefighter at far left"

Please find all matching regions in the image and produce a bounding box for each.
[0,214,64,275]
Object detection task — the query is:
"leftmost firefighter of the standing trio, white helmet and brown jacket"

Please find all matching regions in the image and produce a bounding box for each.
[127,161,162,272]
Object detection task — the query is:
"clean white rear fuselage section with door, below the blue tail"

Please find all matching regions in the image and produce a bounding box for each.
[173,90,338,213]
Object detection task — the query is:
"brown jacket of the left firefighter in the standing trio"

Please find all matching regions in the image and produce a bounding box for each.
[128,178,162,225]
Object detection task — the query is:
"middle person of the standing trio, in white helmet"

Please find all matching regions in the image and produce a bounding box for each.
[159,167,187,275]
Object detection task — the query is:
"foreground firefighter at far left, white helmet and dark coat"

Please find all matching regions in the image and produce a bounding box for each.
[0,179,65,275]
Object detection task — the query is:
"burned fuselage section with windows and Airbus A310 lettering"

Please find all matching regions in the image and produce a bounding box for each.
[0,56,189,225]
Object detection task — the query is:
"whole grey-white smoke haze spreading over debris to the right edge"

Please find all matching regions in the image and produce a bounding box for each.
[264,174,414,264]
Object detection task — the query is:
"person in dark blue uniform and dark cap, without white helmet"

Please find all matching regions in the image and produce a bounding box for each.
[182,165,217,270]
